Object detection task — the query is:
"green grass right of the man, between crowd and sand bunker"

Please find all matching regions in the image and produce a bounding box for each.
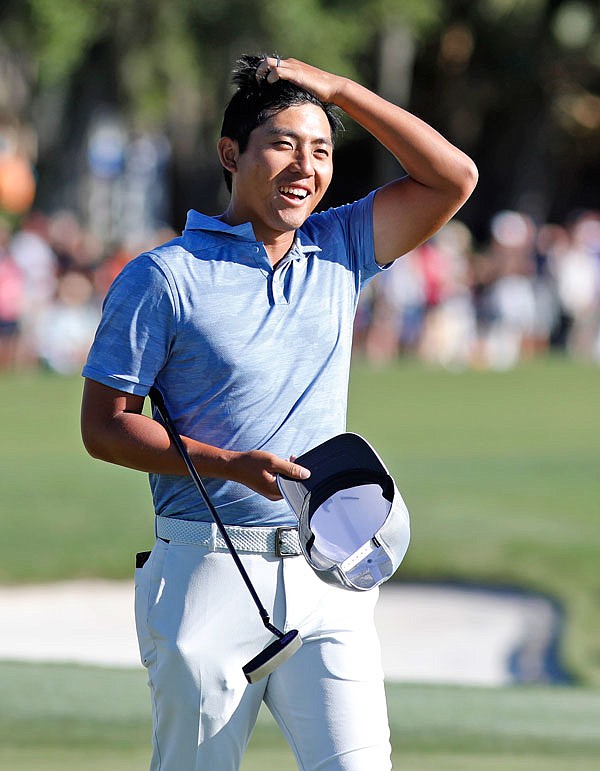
[349,359,600,684]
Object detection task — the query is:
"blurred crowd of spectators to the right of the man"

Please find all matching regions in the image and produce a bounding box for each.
[356,211,600,370]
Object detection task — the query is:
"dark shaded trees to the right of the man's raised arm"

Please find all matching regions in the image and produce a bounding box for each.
[412,0,600,237]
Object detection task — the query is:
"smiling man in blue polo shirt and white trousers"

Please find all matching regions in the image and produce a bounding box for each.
[82,57,477,771]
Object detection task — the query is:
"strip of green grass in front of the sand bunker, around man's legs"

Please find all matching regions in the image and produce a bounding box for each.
[0,663,600,771]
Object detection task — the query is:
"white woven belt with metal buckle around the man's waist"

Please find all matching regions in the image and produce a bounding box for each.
[155,516,302,557]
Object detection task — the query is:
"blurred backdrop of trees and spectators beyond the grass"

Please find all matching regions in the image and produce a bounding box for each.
[0,0,600,374]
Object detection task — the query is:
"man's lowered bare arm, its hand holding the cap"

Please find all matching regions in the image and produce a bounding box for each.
[81,379,308,500]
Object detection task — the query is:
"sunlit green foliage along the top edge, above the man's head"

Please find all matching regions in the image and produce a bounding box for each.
[7,0,440,124]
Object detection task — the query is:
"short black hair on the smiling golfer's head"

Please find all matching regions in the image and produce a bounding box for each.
[221,54,344,192]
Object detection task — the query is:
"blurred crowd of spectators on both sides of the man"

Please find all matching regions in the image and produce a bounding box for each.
[0,205,600,374]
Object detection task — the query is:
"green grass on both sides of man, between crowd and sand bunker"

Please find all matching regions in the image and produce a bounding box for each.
[0,359,600,685]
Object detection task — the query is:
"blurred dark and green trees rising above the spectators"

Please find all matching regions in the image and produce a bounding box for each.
[0,0,600,235]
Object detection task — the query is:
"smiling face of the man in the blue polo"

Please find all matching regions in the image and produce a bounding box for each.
[227,103,333,242]
